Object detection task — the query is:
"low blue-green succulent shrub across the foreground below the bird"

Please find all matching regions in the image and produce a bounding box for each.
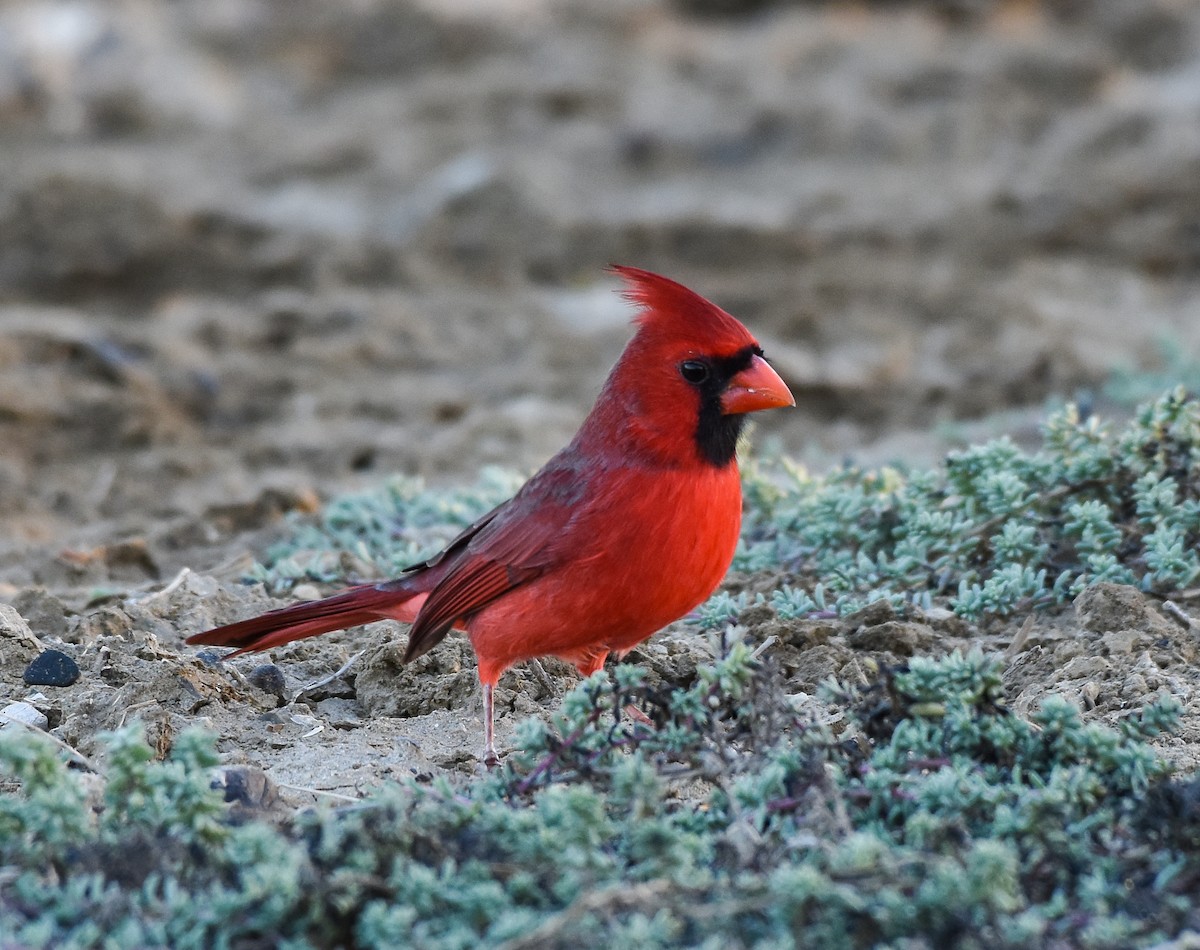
[0,638,1200,948]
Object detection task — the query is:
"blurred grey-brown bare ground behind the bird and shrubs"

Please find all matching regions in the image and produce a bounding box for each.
[0,0,1200,593]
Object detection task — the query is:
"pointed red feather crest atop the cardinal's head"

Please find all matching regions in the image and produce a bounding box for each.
[610,264,755,353]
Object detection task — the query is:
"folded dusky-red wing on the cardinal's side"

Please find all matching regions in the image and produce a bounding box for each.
[404,452,587,662]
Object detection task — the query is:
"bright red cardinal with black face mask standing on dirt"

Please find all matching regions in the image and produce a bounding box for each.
[187,267,796,766]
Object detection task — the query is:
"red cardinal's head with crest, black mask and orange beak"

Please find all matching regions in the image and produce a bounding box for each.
[583,266,796,467]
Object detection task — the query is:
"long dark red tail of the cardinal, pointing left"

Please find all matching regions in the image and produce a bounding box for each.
[187,584,427,656]
